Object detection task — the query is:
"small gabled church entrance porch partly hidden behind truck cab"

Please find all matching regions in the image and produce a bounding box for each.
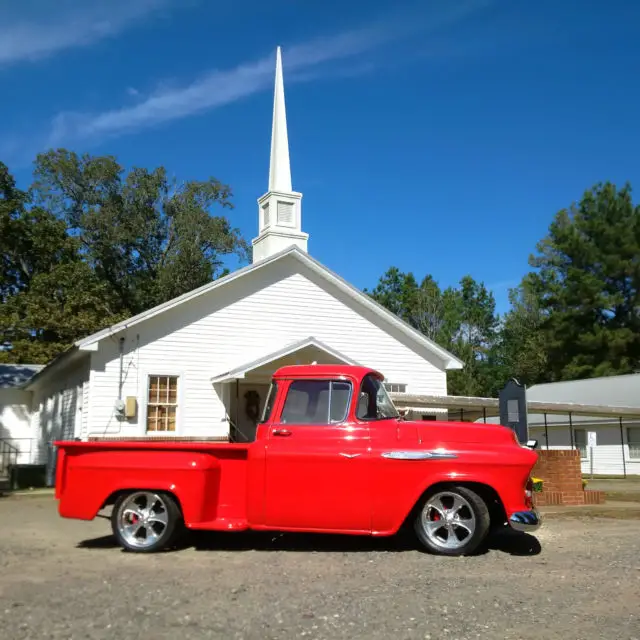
[211,337,358,442]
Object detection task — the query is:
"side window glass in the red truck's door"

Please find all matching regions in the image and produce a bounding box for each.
[280,380,351,424]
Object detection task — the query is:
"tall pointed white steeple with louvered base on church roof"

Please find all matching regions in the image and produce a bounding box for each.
[252,47,309,262]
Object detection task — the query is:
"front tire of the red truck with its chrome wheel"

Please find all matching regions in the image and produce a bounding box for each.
[414,485,491,556]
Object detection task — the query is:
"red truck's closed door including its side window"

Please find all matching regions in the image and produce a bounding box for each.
[265,380,371,533]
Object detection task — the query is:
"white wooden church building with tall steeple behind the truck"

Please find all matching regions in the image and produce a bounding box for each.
[0,48,462,480]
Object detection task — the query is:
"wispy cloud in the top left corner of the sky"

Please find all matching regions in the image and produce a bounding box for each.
[0,0,170,67]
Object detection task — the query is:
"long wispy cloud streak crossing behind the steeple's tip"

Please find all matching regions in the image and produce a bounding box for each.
[2,0,492,162]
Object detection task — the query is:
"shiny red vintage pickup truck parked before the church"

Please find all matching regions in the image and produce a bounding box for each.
[56,365,540,555]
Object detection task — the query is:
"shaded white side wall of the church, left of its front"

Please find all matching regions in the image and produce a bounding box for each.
[30,356,89,464]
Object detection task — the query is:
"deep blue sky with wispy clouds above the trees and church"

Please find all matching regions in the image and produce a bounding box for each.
[0,0,640,311]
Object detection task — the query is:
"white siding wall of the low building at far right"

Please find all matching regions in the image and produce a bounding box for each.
[529,423,640,476]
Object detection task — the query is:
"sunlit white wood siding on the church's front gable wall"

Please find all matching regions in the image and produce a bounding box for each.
[87,258,446,436]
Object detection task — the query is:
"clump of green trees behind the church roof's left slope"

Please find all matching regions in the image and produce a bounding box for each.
[0,149,249,363]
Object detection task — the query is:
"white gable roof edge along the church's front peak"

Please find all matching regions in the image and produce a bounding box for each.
[74,246,463,369]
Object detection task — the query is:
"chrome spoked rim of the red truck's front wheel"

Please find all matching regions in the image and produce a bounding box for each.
[420,491,476,551]
